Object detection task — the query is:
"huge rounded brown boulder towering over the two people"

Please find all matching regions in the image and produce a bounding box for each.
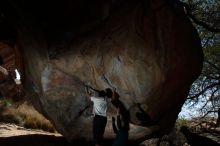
[0,0,203,140]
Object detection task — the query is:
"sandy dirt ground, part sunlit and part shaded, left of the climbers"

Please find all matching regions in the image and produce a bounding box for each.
[0,123,140,146]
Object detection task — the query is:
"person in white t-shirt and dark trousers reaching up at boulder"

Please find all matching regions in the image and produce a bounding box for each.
[87,88,112,146]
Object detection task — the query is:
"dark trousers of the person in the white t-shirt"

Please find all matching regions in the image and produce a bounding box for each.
[93,115,107,145]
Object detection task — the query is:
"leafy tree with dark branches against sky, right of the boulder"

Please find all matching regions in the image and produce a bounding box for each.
[179,0,220,126]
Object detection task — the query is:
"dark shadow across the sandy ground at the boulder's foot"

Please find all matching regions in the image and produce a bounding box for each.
[0,134,140,146]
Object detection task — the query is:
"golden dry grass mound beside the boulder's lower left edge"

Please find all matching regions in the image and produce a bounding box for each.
[0,101,56,132]
